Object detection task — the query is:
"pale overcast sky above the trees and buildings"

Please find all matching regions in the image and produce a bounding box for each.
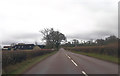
[0,0,119,45]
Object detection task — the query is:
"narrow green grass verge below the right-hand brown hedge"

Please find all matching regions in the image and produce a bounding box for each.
[71,51,120,64]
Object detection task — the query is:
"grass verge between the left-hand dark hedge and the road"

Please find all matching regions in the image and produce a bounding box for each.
[2,51,57,74]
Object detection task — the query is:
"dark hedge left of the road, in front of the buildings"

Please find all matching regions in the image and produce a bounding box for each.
[2,49,54,68]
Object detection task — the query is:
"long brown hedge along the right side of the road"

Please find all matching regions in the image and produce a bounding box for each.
[65,44,118,57]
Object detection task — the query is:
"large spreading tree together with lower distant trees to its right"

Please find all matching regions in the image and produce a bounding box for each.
[41,28,119,50]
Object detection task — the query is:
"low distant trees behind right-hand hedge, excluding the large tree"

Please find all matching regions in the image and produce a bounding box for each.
[62,35,119,47]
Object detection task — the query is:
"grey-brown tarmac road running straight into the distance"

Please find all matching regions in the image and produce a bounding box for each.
[25,48,118,76]
